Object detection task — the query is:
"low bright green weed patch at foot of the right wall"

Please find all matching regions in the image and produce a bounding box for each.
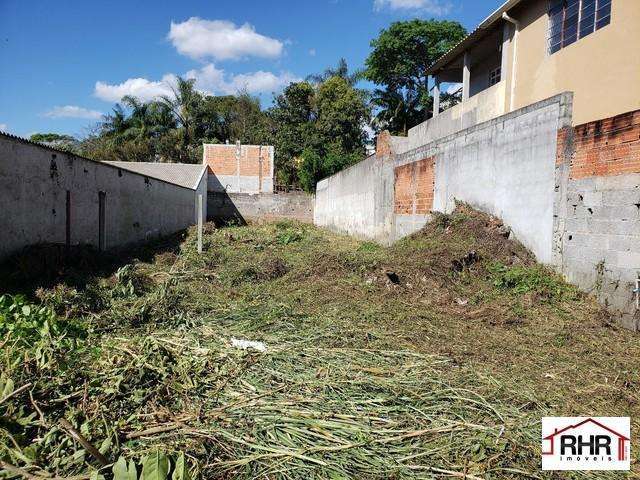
[489,262,577,300]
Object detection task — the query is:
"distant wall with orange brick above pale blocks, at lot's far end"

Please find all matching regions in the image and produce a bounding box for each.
[203,144,274,193]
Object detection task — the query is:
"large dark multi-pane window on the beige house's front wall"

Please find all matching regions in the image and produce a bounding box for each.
[549,0,612,53]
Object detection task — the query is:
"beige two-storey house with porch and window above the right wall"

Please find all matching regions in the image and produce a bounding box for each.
[423,0,640,126]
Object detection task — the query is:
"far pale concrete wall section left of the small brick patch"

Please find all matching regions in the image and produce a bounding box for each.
[314,156,394,243]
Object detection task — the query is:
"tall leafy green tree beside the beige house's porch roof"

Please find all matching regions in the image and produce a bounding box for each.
[363,19,466,134]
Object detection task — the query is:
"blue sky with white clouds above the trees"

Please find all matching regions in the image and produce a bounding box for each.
[0,0,502,136]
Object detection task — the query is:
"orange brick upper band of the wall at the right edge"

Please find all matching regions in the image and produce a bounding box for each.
[558,110,640,179]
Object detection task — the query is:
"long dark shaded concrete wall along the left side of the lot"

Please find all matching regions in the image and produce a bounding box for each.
[0,135,206,258]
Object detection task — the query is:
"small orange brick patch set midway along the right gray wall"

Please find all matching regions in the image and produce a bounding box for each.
[394,157,434,215]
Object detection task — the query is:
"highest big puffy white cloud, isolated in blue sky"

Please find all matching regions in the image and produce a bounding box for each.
[168,17,284,60]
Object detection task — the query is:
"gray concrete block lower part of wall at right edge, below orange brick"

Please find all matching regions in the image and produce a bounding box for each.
[562,174,640,329]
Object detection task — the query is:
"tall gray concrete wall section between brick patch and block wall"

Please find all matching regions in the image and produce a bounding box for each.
[395,95,571,264]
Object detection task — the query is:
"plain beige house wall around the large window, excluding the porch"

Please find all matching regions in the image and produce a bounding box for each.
[505,0,640,125]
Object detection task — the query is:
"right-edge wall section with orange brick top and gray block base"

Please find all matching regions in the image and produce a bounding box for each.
[557,111,640,330]
